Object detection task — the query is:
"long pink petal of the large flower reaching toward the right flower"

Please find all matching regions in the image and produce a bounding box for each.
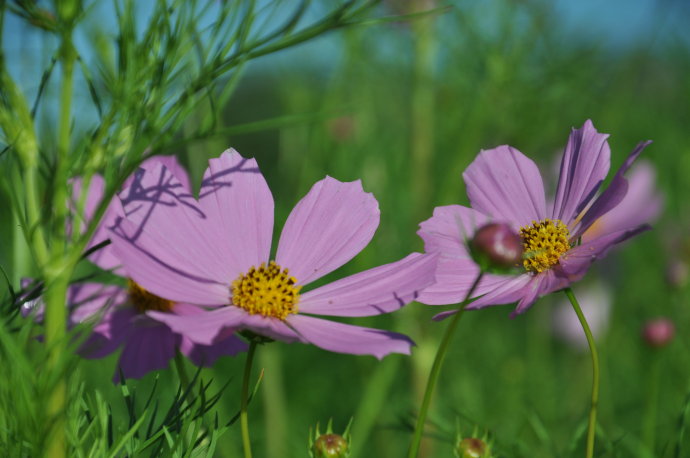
[299,253,438,316]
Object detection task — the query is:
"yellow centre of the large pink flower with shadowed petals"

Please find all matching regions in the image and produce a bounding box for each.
[231,261,302,320]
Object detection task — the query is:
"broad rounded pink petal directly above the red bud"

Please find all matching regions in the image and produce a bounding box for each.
[463,145,546,227]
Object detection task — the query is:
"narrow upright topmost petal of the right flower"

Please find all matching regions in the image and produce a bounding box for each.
[553,120,611,225]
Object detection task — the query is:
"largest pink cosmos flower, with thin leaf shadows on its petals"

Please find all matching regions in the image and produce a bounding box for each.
[112,150,436,358]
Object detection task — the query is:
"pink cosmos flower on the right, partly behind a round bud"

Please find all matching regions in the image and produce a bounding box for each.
[417,121,650,319]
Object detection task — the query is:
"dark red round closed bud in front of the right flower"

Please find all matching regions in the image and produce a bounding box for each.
[470,223,522,269]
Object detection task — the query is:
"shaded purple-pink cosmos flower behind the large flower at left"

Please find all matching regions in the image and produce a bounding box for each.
[23,156,247,382]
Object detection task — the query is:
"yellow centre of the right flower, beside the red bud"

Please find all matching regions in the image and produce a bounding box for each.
[520,218,570,273]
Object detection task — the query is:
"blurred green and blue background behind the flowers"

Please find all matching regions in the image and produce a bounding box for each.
[0,0,690,457]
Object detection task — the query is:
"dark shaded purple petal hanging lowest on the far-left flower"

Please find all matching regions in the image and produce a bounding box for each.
[113,320,179,383]
